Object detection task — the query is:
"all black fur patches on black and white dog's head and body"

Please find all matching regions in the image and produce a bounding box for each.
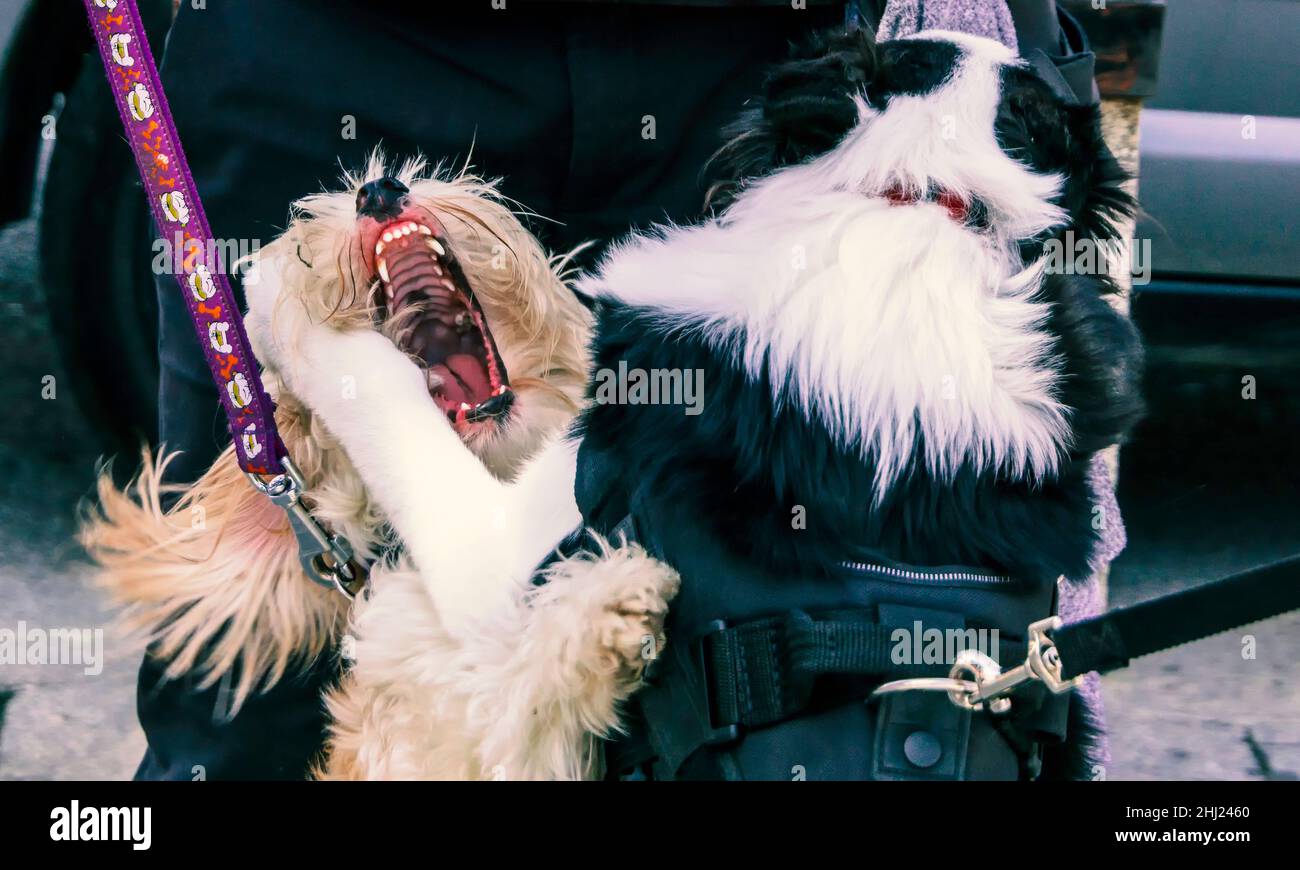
[582,33,1141,581]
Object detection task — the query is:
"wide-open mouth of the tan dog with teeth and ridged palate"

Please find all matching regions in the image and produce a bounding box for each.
[363,213,515,429]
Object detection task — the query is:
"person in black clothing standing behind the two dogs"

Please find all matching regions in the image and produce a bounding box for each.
[137,0,1092,779]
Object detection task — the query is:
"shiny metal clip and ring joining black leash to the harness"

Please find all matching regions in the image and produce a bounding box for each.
[871,616,1083,715]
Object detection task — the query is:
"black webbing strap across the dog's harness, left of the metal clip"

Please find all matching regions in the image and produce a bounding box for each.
[701,611,1026,728]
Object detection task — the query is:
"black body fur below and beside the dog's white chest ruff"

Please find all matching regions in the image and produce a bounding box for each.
[584,267,1141,580]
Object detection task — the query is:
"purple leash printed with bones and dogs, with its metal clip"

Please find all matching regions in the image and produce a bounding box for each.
[83,0,365,597]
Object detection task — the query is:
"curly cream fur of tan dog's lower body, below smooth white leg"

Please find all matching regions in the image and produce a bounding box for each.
[320,545,677,780]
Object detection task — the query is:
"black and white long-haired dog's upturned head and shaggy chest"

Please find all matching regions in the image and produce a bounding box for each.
[581,25,1141,598]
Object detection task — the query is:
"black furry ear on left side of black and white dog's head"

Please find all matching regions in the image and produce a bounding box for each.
[712,30,876,202]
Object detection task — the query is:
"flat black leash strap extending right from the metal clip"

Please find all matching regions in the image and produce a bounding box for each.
[1052,557,1300,680]
